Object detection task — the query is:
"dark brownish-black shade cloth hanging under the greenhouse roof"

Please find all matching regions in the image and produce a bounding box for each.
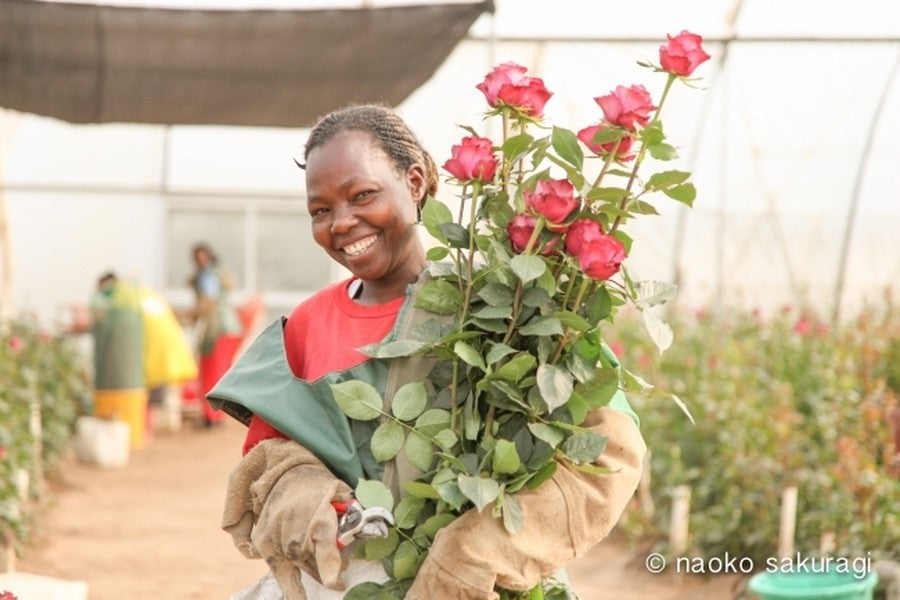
[0,0,492,127]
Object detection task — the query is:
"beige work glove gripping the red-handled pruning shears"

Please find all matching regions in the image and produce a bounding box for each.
[222,439,353,600]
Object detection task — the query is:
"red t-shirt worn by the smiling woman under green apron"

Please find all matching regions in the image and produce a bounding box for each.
[244,278,404,454]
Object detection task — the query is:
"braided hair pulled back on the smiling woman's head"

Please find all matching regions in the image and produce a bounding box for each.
[298,104,438,202]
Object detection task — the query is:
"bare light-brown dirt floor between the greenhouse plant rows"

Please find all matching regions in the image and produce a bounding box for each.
[16,412,739,600]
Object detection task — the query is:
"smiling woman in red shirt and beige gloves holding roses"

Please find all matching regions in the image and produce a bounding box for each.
[213,105,644,600]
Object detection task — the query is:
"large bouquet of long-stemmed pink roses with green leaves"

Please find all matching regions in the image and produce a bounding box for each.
[333,31,709,600]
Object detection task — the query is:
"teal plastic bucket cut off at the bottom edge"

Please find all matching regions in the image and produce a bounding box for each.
[747,571,878,600]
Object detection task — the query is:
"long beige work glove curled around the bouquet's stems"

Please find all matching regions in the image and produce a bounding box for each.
[406,407,646,600]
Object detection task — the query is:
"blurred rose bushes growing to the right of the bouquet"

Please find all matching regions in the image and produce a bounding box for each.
[607,294,900,564]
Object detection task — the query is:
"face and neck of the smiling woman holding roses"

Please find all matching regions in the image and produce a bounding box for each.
[306,131,427,304]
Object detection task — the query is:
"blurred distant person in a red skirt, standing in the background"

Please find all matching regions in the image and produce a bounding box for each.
[190,243,242,427]
